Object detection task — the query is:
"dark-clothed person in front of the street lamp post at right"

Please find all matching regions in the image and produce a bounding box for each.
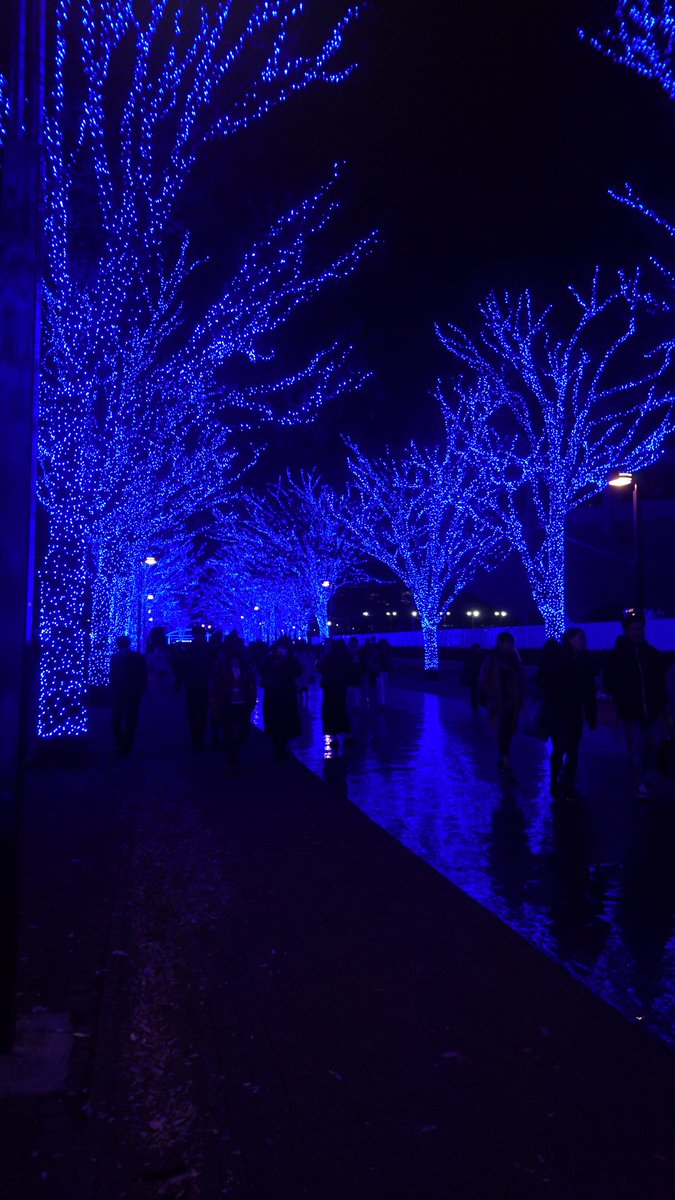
[603,608,668,799]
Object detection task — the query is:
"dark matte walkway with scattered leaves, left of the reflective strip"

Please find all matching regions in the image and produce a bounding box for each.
[0,690,675,1200]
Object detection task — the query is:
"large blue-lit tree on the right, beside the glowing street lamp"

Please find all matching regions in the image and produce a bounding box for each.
[440,275,674,637]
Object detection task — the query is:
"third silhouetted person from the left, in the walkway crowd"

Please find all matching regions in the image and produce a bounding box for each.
[209,632,256,769]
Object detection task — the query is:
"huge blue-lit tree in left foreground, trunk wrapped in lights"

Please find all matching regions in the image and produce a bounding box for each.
[36,0,364,737]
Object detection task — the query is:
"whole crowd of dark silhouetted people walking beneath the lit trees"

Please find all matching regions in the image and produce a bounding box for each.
[110,610,675,799]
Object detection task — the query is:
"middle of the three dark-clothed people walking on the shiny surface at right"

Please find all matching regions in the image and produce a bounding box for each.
[537,629,597,798]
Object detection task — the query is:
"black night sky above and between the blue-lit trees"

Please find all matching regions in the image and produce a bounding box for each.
[192,0,674,461]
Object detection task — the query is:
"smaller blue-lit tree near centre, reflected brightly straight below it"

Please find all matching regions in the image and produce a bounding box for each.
[345,391,503,671]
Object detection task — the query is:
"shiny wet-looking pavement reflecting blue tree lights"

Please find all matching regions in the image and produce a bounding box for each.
[254,680,675,1046]
